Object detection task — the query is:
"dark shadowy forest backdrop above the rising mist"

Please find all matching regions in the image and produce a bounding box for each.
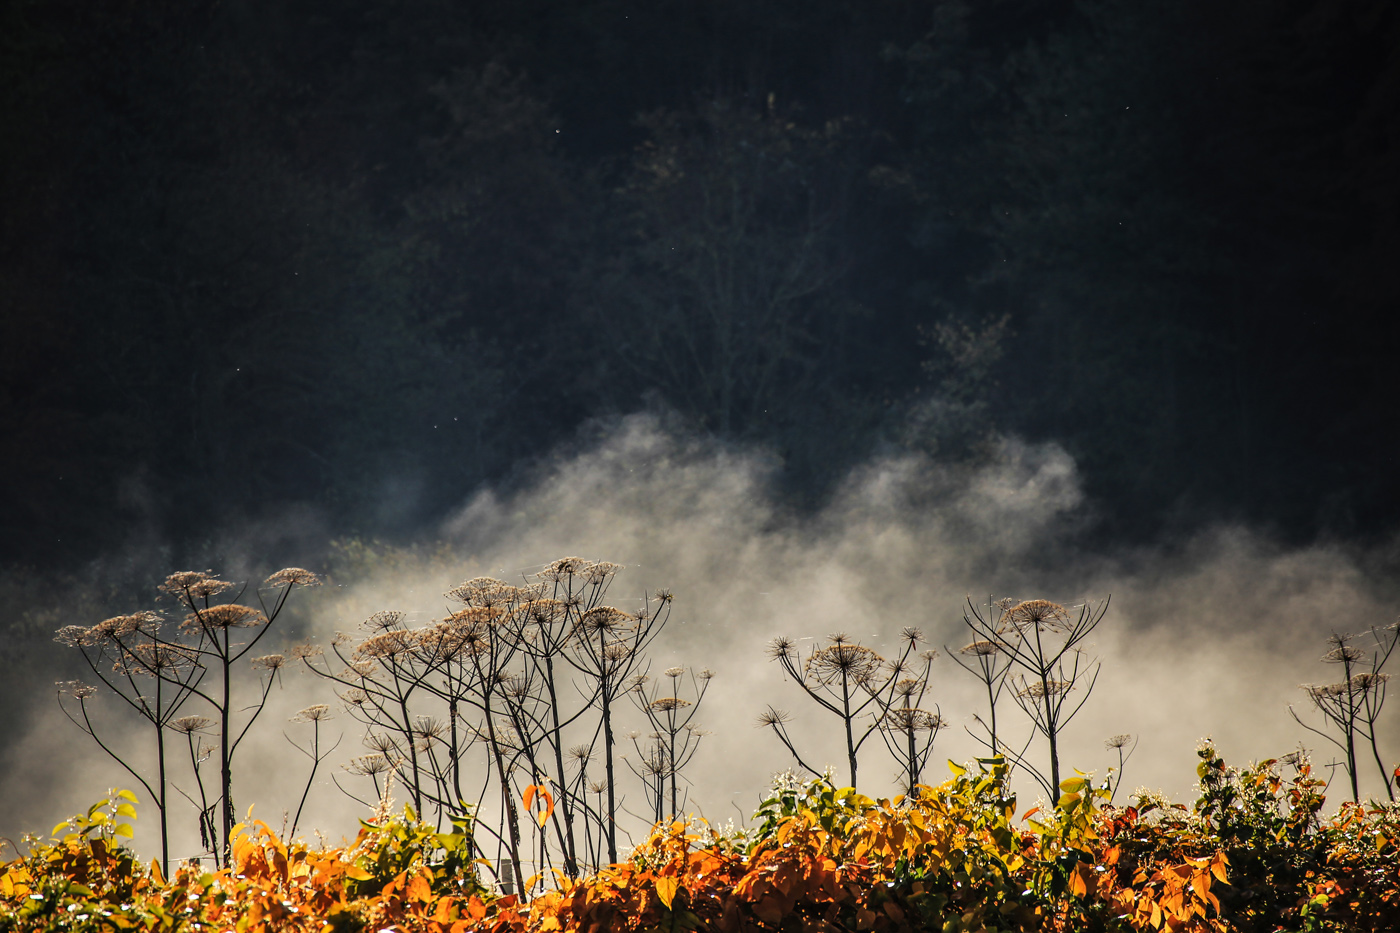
[0,0,1400,567]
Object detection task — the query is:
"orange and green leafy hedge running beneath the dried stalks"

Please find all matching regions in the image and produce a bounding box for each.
[0,742,1400,933]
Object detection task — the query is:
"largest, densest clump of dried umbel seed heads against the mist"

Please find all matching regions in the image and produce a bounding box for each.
[294,558,680,892]
